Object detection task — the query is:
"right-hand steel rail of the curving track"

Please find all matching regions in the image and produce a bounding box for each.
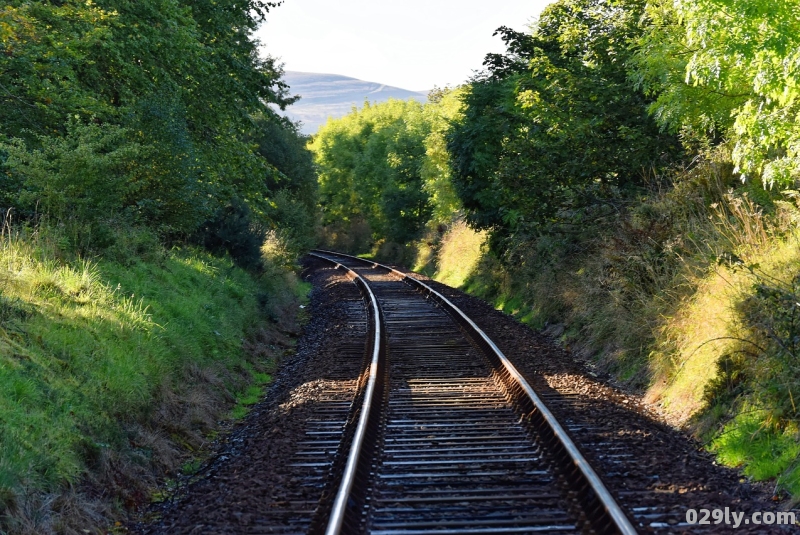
[311,250,637,535]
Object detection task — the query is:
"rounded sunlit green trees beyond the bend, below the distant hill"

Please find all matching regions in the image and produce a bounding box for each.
[310,100,431,243]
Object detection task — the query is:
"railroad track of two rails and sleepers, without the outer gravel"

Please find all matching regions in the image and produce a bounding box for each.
[309,251,636,535]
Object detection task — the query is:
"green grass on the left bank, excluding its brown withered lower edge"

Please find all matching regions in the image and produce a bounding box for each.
[0,226,288,524]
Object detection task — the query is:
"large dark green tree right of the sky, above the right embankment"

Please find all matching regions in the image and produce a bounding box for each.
[449,0,679,239]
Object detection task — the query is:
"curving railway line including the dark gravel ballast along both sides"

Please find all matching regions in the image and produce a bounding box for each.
[142,251,791,535]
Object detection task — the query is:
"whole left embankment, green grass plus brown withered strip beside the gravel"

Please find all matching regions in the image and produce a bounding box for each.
[0,227,306,533]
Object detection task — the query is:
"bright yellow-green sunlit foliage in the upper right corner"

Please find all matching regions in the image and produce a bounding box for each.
[635,0,800,187]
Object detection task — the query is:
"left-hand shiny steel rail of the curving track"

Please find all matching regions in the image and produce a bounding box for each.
[309,252,382,535]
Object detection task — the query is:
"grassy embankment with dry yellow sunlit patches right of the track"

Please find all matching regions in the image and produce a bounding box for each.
[398,155,800,498]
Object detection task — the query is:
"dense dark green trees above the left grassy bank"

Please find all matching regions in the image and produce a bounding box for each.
[0,0,314,239]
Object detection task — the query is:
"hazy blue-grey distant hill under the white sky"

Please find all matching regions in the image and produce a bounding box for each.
[283,71,428,134]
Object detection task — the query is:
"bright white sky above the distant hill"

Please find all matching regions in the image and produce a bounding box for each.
[256,0,551,91]
